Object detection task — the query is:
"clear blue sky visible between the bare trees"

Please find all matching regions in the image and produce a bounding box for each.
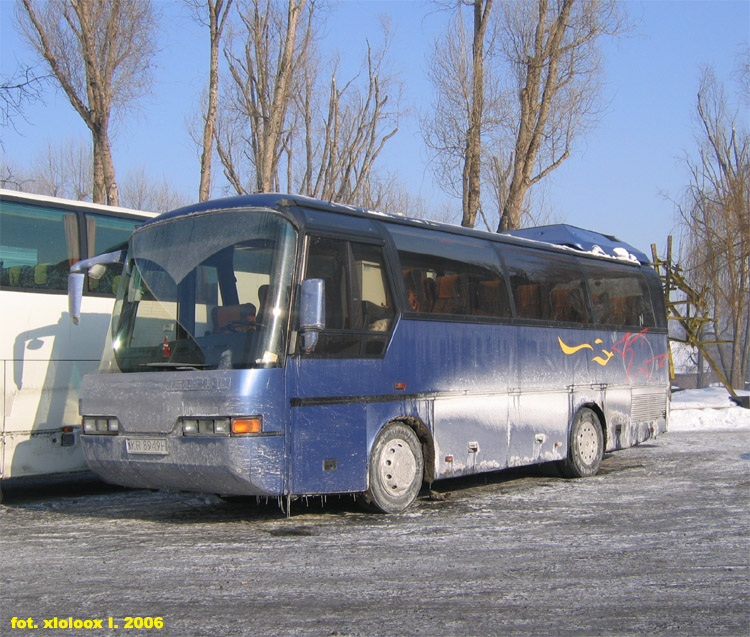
[0,0,750,251]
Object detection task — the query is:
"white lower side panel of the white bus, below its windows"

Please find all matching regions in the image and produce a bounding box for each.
[0,291,113,479]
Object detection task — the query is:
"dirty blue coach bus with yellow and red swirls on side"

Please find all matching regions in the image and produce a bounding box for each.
[71,194,669,512]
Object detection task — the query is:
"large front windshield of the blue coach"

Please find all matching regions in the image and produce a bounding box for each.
[100,209,297,372]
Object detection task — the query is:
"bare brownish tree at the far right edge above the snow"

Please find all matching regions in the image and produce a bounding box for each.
[679,69,750,388]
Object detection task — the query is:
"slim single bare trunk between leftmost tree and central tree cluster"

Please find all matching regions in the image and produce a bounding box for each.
[185,0,233,201]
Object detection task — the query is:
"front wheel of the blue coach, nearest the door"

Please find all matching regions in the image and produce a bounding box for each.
[364,423,424,513]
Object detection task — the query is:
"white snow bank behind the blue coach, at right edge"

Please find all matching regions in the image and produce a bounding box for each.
[669,387,750,431]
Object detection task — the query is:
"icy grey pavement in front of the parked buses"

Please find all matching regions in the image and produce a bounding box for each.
[0,428,750,637]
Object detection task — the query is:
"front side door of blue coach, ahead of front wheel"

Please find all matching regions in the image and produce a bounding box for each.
[287,236,398,494]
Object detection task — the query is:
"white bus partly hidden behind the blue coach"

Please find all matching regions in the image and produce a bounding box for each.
[0,189,155,498]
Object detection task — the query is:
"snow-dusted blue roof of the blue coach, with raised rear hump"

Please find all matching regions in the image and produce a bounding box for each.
[144,193,651,265]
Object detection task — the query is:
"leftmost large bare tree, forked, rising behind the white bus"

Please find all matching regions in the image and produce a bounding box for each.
[18,0,156,205]
